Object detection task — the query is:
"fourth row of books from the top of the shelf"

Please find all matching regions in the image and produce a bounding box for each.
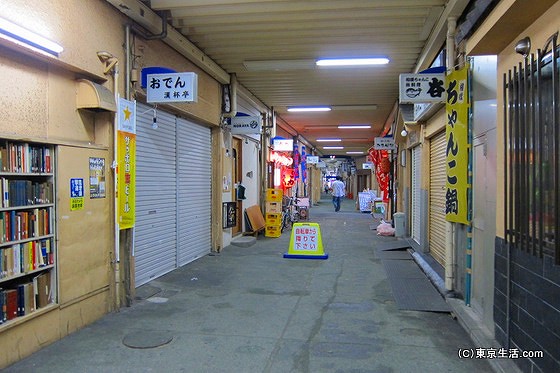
[0,238,54,279]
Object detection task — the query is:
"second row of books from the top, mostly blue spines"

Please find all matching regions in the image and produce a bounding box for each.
[0,177,53,207]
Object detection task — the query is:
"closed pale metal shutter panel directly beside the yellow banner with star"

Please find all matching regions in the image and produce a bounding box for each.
[134,104,177,286]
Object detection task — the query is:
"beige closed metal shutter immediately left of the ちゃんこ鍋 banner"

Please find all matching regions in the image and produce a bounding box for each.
[428,131,446,266]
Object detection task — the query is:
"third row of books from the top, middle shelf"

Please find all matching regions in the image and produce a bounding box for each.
[0,207,52,243]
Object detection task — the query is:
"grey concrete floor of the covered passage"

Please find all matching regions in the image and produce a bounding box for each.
[5,195,493,373]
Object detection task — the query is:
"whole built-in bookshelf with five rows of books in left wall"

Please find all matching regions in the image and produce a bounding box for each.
[0,139,56,326]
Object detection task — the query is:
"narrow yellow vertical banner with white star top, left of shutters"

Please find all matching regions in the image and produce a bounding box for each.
[116,98,136,229]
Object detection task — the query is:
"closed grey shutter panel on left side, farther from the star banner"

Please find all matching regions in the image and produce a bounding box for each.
[177,118,212,266]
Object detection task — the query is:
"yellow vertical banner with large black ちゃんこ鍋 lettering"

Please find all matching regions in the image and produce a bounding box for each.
[445,64,470,224]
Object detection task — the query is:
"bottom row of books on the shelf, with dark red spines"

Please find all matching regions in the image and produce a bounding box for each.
[0,273,53,324]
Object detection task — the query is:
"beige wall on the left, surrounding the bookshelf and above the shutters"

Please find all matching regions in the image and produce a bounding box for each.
[0,0,221,369]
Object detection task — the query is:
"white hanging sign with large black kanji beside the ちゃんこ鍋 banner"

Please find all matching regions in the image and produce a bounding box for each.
[399,74,445,104]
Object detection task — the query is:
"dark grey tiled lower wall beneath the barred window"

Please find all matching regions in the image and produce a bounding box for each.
[494,237,560,372]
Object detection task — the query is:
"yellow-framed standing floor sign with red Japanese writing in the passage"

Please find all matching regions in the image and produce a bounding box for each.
[284,223,329,259]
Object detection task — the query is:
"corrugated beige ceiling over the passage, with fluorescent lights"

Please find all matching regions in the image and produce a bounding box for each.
[145,0,468,155]
